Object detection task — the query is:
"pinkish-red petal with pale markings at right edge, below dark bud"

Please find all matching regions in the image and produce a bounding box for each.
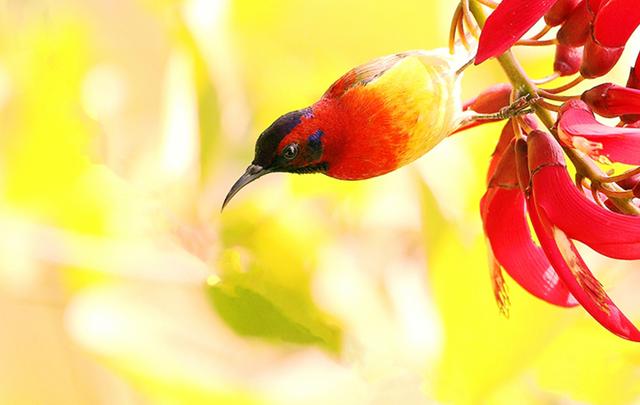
[557,100,640,164]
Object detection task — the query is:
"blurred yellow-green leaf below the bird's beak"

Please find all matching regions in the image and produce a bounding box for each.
[208,206,342,353]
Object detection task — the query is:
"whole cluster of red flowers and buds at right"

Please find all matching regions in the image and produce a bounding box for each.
[463,0,640,341]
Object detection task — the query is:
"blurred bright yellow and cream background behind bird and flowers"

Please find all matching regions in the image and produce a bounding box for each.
[0,0,640,405]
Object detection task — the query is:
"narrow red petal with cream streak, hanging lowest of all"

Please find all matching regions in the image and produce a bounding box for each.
[527,192,640,341]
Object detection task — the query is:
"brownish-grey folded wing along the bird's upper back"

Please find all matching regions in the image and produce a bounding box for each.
[323,52,414,98]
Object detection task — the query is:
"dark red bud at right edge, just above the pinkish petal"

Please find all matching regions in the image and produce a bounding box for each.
[581,83,640,117]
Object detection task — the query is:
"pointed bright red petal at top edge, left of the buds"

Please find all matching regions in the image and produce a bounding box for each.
[475,0,556,65]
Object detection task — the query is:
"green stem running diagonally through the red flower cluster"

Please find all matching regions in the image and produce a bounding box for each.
[469,0,640,215]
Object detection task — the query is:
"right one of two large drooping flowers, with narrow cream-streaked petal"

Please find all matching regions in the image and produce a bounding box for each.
[519,131,640,341]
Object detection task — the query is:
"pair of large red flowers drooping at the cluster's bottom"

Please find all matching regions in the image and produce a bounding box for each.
[481,130,640,341]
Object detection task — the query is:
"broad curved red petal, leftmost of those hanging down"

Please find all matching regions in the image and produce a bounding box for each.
[480,188,577,306]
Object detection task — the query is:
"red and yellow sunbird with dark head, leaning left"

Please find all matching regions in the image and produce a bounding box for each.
[222,50,523,209]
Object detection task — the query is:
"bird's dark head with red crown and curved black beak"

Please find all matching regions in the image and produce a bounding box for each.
[222,108,328,209]
